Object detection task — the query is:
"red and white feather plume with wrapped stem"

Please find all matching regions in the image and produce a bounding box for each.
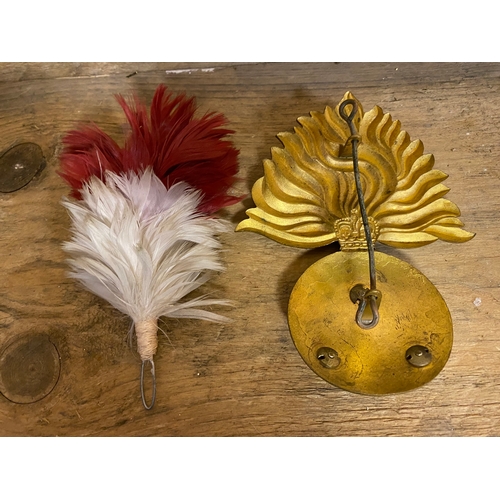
[59,85,241,407]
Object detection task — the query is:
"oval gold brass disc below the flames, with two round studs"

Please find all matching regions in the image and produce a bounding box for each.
[288,252,453,394]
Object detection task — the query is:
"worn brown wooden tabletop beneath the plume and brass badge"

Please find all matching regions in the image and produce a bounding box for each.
[0,63,500,436]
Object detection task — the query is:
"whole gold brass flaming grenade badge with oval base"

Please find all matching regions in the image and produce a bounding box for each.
[236,92,474,394]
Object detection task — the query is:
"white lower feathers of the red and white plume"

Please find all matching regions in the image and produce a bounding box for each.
[62,169,229,324]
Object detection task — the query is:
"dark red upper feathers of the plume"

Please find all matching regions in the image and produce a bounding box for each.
[59,85,241,214]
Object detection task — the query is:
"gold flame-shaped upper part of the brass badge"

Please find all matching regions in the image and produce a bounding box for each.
[236,92,474,250]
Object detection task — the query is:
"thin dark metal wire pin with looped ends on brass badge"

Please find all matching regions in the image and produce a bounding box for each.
[339,99,381,329]
